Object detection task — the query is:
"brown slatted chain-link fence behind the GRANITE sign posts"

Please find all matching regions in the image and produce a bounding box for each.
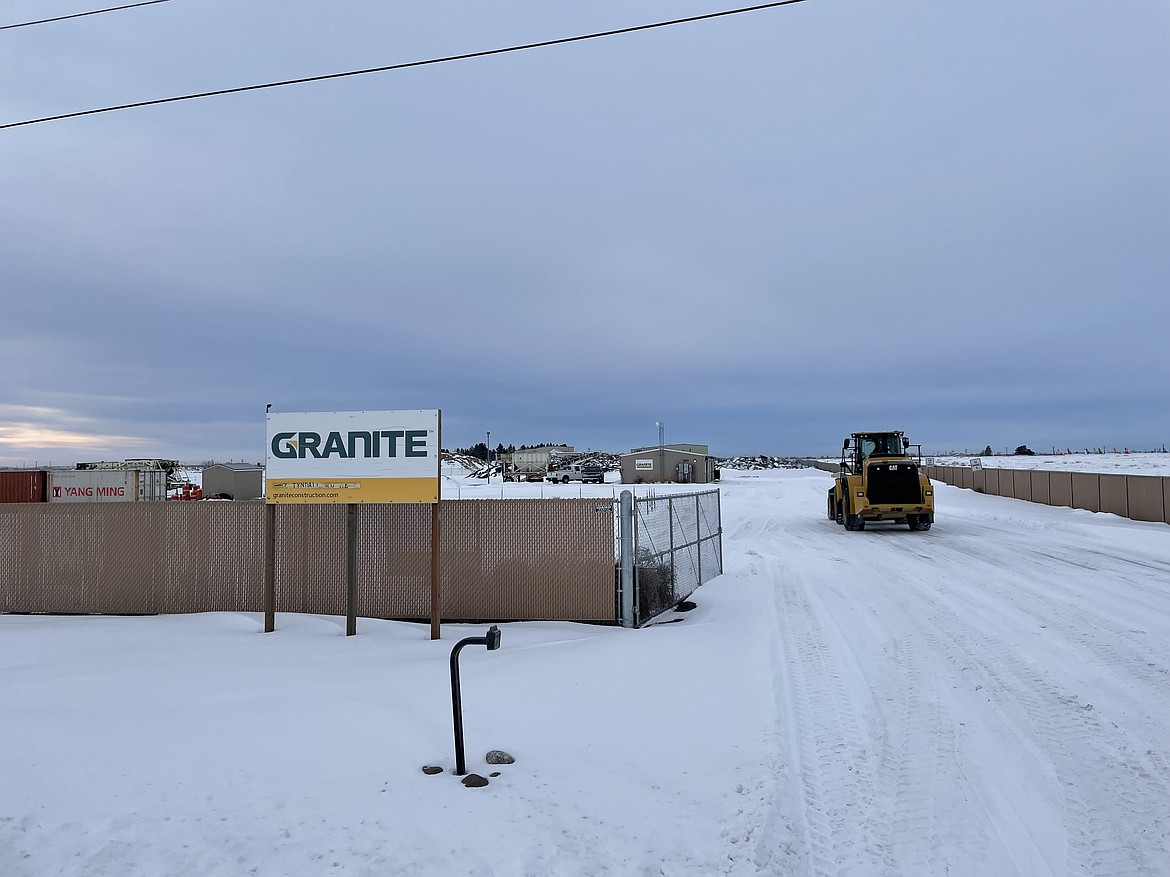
[0,499,617,622]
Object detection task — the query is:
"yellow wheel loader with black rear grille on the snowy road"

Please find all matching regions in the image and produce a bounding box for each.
[828,430,935,530]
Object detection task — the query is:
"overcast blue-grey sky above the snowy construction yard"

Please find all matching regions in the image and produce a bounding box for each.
[0,0,1170,465]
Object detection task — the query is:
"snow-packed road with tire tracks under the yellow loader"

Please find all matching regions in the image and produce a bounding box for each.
[725,472,1170,876]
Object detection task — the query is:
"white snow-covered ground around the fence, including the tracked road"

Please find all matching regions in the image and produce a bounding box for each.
[0,463,1170,877]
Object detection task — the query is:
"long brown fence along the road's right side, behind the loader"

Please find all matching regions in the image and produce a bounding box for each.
[925,465,1170,524]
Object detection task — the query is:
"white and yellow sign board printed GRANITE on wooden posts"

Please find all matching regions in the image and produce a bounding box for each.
[264,409,441,503]
